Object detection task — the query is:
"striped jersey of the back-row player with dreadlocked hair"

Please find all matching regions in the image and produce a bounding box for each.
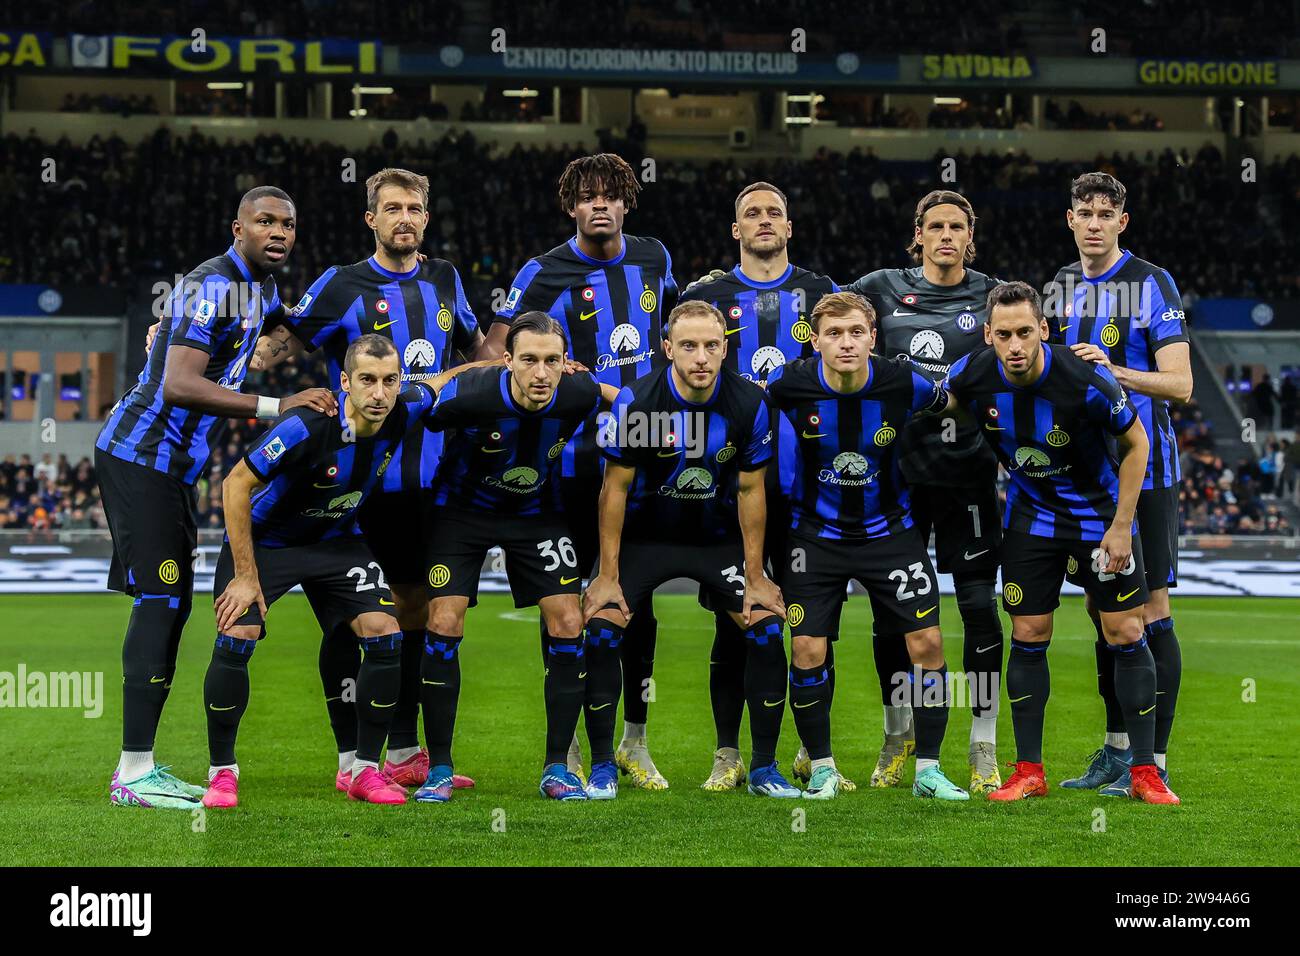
[497,234,677,479]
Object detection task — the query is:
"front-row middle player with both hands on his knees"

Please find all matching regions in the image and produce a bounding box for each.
[584,302,800,800]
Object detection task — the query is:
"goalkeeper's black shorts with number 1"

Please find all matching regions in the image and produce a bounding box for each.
[909,483,1002,575]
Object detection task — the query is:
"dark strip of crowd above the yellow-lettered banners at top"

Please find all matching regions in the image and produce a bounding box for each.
[0,0,1300,56]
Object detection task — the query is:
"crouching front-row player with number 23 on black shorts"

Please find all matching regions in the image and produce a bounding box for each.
[750,293,970,800]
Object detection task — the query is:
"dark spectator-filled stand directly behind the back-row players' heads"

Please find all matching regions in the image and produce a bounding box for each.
[0,130,1300,299]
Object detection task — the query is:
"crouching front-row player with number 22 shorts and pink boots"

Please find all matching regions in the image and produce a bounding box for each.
[203,336,488,808]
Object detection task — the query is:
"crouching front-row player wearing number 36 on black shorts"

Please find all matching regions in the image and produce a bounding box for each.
[415,312,618,803]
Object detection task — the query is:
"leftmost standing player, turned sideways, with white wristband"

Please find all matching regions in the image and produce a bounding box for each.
[95,186,338,809]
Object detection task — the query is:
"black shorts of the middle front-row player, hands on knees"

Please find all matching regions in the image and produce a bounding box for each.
[619,537,745,614]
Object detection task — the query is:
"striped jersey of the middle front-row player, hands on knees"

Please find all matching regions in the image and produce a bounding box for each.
[601,365,772,544]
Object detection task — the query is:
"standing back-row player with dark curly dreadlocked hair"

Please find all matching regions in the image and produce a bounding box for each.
[484,152,677,790]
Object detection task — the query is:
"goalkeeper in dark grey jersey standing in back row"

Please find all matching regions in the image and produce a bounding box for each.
[849,190,1004,793]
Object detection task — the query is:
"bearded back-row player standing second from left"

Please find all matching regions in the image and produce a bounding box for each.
[246,168,482,790]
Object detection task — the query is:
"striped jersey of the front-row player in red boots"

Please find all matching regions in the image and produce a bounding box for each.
[944,342,1138,541]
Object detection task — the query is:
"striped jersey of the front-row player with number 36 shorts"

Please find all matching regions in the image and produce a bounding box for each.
[428,367,601,515]
